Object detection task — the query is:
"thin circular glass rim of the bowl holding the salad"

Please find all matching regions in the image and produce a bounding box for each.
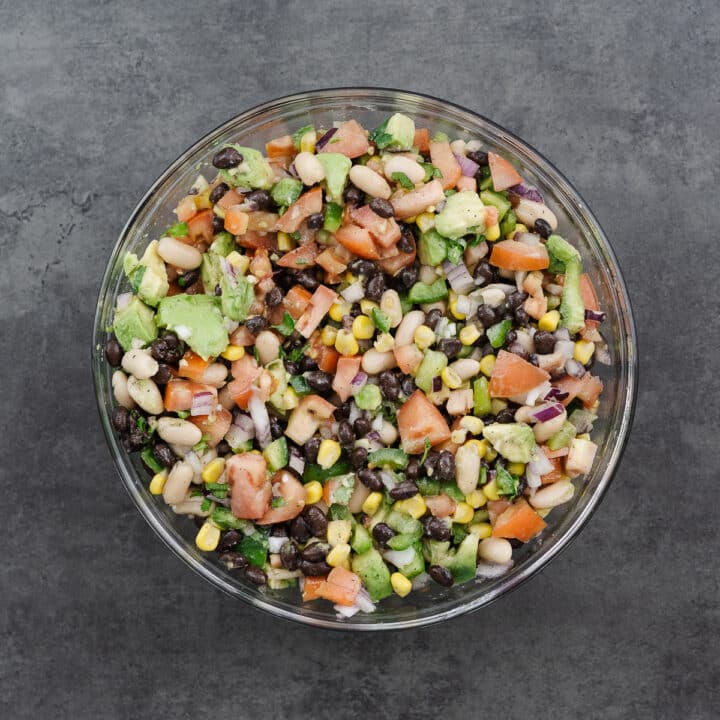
[91,85,639,631]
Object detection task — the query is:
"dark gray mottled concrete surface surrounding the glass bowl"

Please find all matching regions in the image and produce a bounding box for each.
[0,0,720,720]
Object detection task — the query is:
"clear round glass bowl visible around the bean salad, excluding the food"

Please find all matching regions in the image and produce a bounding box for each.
[92,88,637,630]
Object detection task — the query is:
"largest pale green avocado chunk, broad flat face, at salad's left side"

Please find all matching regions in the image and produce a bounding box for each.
[156,295,228,360]
